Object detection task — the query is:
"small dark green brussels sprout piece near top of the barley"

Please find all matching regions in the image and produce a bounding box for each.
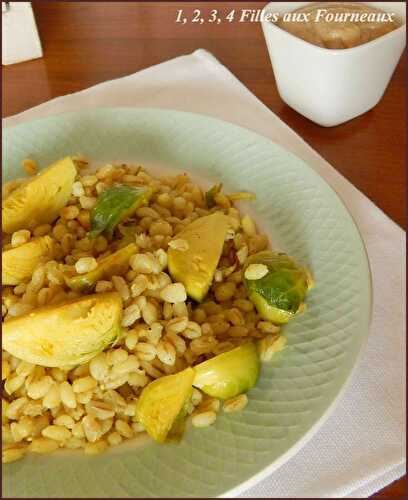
[89,185,153,238]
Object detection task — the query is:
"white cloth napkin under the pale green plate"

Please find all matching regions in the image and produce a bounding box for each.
[3,49,406,498]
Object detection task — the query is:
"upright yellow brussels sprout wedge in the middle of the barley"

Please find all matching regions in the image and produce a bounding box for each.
[167,212,228,302]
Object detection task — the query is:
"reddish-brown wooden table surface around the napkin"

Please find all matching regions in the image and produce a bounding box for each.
[3,1,406,497]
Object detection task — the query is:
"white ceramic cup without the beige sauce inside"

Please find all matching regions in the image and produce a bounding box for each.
[262,2,406,127]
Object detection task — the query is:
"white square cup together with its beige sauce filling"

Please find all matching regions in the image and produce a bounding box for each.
[262,2,406,127]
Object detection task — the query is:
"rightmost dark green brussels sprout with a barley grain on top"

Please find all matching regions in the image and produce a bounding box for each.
[243,250,313,324]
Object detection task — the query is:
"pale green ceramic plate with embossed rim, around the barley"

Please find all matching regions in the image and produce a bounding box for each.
[3,109,371,498]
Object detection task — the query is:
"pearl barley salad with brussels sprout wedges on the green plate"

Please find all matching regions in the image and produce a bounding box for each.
[2,157,312,463]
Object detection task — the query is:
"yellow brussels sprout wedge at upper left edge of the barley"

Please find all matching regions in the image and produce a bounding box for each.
[2,157,77,234]
